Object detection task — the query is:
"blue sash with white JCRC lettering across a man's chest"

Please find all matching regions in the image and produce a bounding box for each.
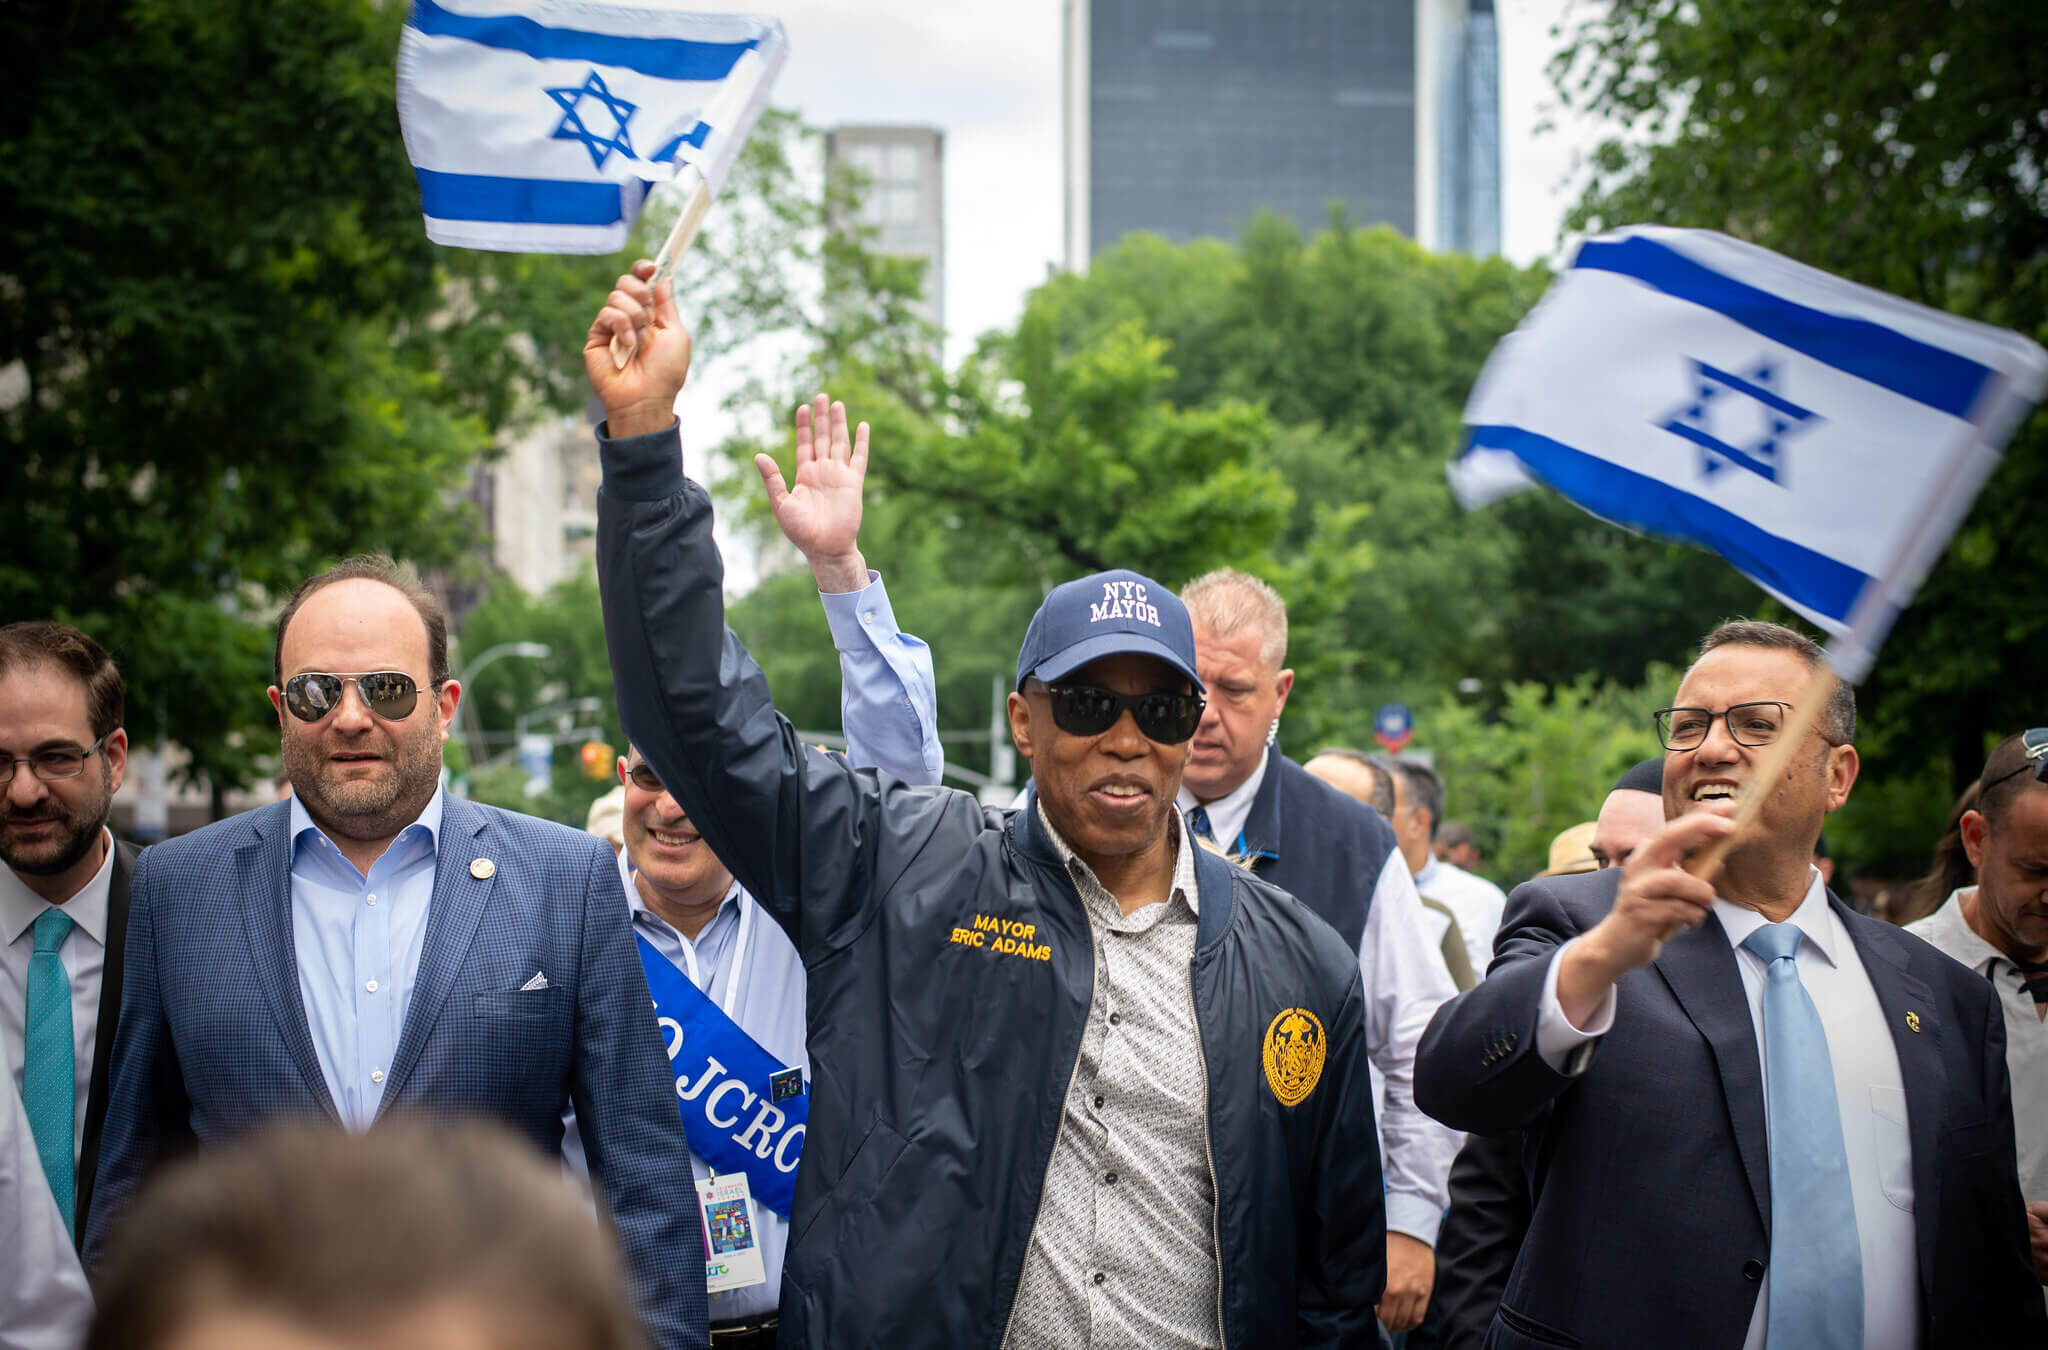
[635,934,811,1219]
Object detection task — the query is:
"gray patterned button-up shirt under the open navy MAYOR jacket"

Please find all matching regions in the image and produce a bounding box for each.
[1004,809,1223,1350]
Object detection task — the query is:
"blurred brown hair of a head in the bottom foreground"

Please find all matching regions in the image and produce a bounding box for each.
[86,1121,638,1350]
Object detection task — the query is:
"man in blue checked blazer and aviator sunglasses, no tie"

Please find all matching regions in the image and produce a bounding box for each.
[86,557,707,1348]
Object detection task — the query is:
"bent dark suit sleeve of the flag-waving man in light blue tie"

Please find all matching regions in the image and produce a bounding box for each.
[1415,881,1597,1135]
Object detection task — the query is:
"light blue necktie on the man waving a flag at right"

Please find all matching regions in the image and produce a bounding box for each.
[1743,924,1864,1350]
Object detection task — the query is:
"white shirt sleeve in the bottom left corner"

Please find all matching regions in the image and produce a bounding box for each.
[0,1036,92,1350]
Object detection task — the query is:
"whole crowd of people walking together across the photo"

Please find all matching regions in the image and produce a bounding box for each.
[0,264,2048,1350]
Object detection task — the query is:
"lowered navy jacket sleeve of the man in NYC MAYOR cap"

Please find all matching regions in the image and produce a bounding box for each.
[1294,967,1386,1350]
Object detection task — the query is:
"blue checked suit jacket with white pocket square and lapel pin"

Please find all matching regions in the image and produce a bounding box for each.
[86,797,709,1348]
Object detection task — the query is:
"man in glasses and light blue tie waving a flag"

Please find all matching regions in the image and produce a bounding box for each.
[1415,621,2048,1350]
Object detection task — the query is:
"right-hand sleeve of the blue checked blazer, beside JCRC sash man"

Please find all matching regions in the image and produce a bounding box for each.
[569,840,711,1350]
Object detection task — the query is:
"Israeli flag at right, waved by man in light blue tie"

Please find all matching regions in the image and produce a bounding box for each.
[1450,225,2048,684]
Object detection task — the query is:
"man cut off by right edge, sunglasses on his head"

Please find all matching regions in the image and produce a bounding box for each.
[1907,727,2048,1284]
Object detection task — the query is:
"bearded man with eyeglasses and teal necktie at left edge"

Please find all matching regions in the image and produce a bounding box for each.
[0,621,137,1344]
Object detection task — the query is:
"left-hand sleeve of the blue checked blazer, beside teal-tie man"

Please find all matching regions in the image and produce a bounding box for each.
[84,850,193,1274]
